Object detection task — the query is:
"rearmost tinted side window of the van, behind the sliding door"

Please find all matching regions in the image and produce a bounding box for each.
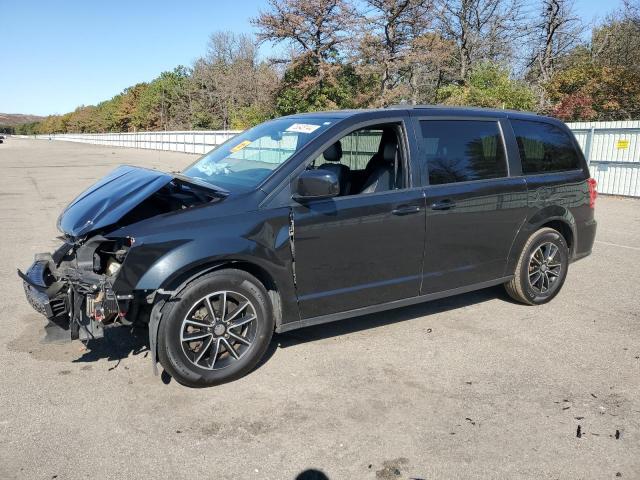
[511,120,580,174]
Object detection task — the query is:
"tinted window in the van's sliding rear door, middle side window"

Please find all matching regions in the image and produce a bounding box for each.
[420,120,507,185]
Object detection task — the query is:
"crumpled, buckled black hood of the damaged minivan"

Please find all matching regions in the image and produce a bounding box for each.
[58,165,222,237]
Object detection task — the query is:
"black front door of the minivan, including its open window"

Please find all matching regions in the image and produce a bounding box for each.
[292,125,425,319]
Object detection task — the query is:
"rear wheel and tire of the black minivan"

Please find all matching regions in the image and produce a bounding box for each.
[504,228,569,305]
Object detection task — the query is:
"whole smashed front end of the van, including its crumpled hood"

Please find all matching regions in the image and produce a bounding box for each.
[18,165,228,340]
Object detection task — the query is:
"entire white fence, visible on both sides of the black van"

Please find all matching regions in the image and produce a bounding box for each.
[27,121,640,197]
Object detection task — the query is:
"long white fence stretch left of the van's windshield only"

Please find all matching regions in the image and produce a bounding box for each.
[31,130,240,154]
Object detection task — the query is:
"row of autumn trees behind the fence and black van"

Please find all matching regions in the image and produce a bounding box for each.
[23,0,640,133]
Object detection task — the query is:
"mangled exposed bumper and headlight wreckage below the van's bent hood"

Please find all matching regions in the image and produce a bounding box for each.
[18,236,134,341]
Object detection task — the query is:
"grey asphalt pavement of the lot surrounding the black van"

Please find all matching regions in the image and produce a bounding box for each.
[0,138,640,480]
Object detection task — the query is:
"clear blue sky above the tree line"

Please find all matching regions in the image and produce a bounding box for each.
[0,0,621,115]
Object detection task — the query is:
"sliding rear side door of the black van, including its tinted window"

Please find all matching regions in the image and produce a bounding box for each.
[418,117,527,294]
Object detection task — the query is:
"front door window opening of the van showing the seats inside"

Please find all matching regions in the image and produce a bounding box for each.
[308,123,404,197]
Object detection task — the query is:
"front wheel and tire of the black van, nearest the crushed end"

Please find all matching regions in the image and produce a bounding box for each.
[158,269,274,387]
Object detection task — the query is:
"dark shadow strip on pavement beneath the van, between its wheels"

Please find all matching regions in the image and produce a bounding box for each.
[272,285,513,348]
